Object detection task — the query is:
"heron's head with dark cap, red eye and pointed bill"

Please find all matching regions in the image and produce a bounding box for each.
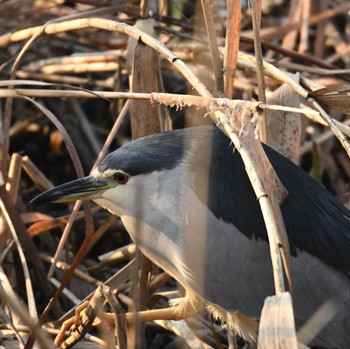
[32,131,194,216]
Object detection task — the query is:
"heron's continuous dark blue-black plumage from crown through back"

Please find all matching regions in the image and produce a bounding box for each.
[99,126,350,271]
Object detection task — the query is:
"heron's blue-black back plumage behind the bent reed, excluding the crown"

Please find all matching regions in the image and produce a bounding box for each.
[205,126,350,271]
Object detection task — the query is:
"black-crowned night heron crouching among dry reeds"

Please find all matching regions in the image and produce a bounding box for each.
[32,127,350,348]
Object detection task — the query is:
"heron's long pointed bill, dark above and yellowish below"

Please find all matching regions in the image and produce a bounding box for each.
[31,176,112,203]
